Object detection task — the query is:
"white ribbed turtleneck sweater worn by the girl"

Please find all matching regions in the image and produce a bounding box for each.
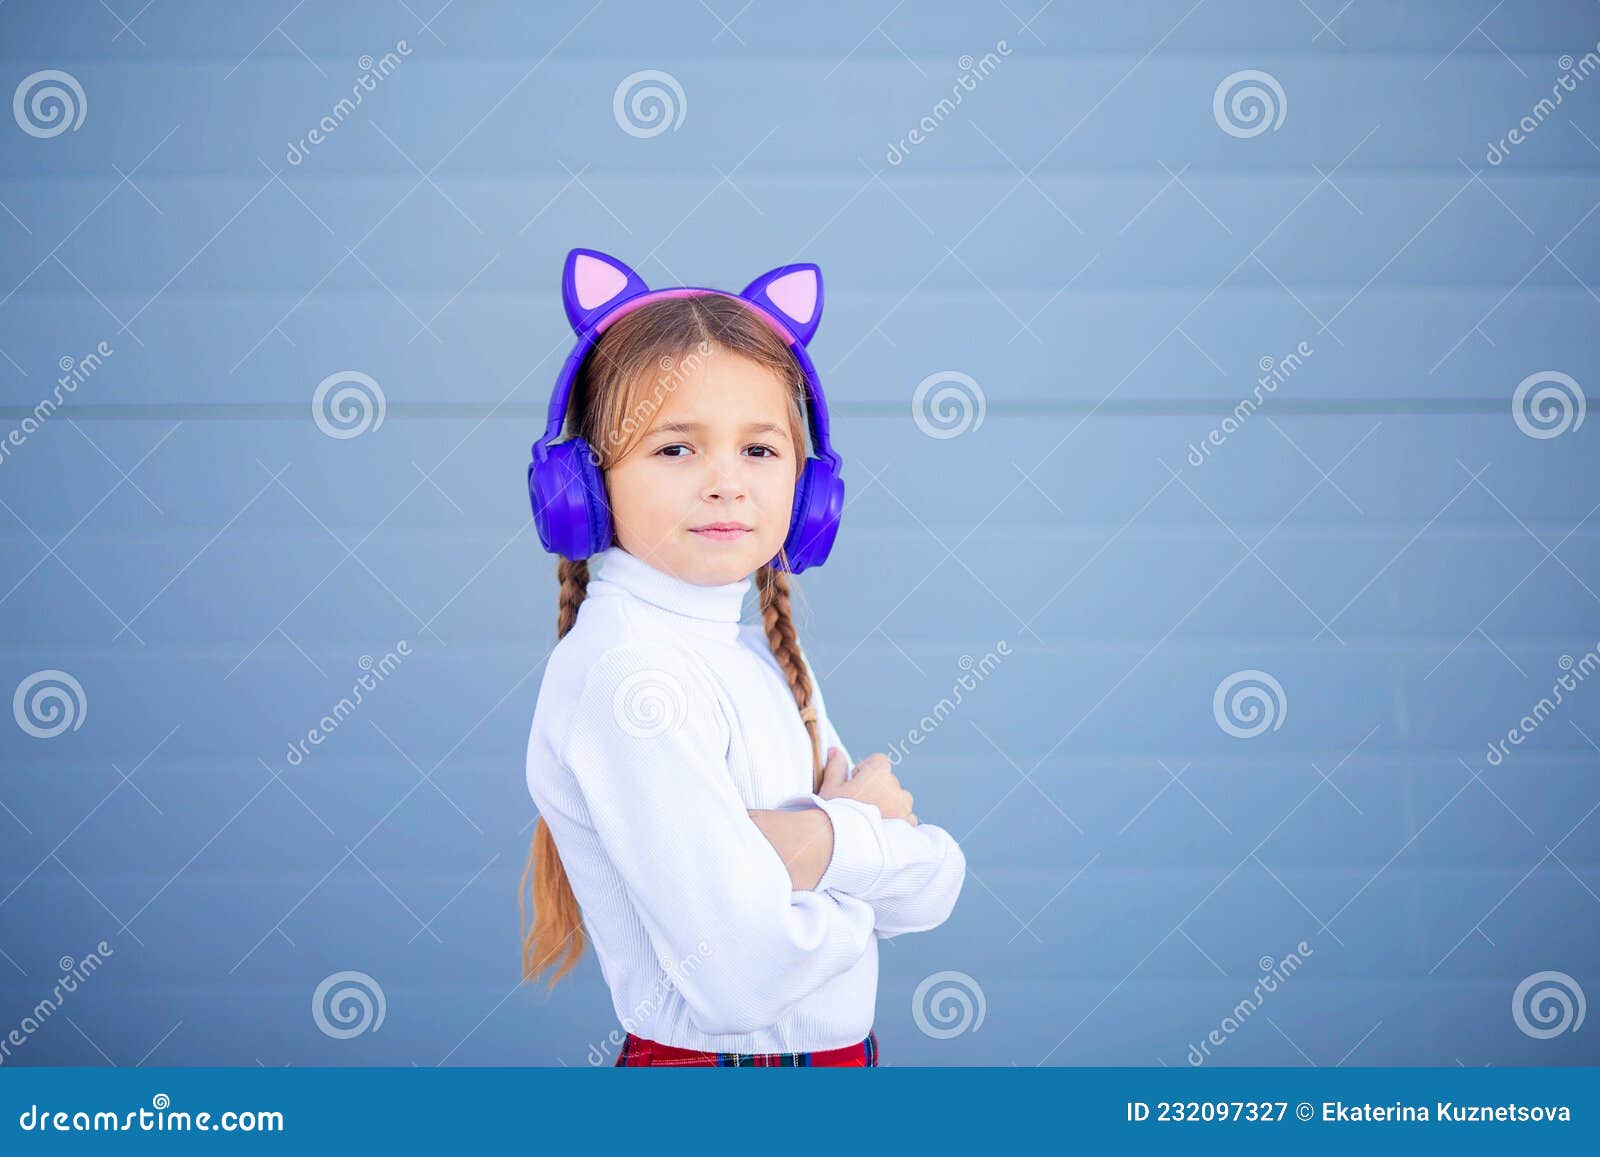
[528,546,966,1053]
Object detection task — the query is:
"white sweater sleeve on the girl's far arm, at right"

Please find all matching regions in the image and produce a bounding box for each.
[808,664,966,938]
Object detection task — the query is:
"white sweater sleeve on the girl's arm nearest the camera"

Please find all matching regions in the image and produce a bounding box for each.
[562,643,874,1034]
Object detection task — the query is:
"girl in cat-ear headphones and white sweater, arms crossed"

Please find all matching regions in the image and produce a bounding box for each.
[518,250,966,1066]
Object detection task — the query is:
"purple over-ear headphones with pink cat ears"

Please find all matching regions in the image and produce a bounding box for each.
[528,250,845,573]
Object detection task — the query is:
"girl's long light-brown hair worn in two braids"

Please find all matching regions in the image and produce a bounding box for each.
[517,294,822,987]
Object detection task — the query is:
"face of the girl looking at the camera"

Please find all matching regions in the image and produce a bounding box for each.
[605,347,798,586]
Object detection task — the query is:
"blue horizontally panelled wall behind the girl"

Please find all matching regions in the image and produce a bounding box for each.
[0,0,1600,1066]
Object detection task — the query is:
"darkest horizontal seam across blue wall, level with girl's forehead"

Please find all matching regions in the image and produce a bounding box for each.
[0,394,1510,426]
